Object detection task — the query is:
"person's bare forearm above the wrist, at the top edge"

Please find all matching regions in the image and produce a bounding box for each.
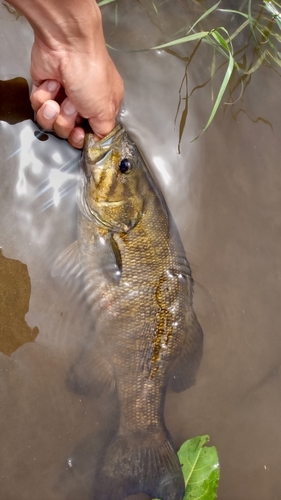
[9,0,105,53]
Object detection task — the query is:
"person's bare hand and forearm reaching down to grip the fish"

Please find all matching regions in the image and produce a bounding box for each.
[7,0,124,148]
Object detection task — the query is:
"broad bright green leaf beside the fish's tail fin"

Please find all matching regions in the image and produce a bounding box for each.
[178,436,219,500]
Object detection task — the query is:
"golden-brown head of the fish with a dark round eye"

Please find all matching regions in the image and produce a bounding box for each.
[82,125,148,232]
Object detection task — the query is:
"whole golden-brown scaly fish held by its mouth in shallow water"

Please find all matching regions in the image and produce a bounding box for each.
[54,124,203,500]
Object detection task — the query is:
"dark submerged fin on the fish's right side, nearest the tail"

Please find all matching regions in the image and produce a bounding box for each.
[169,310,203,392]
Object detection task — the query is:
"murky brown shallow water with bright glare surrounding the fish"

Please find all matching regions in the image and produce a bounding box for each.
[0,1,281,500]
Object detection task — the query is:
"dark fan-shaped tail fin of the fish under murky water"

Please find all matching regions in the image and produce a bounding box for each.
[94,431,185,500]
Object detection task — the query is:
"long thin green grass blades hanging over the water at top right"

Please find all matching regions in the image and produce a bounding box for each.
[152,0,281,143]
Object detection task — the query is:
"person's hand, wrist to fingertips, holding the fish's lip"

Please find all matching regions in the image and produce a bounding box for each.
[31,39,123,148]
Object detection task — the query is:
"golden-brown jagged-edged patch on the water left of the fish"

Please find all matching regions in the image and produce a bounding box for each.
[0,249,39,356]
